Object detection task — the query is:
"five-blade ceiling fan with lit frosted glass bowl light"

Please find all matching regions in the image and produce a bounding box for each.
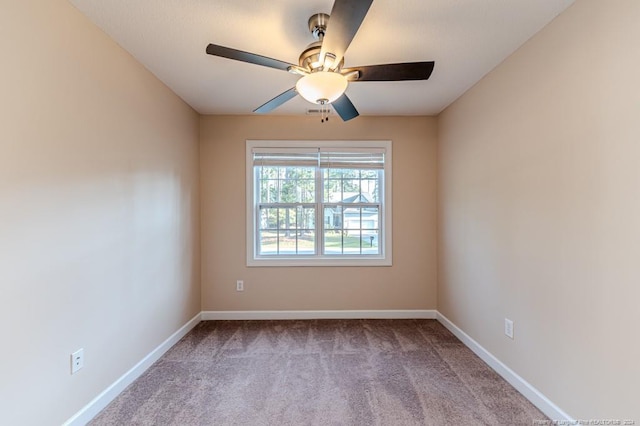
[207,0,434,121]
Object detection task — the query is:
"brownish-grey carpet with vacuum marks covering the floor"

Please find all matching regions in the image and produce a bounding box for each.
[91,320,546,425]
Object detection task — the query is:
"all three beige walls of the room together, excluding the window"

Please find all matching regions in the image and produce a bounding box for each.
[0,0,640,425]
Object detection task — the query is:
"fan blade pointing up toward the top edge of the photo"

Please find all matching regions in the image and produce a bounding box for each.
[320,0,373,69]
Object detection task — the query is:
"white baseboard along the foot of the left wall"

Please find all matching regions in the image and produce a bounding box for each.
[64,313,202,426]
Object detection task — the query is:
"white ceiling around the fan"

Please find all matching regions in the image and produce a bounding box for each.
[69,0,574,115]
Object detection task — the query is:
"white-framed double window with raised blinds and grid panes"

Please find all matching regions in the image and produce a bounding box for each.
[247,141,391,266]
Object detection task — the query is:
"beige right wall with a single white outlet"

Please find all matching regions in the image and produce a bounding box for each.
[438,0,640,423]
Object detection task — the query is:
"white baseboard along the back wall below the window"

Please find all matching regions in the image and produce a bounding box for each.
[202,309,438,321]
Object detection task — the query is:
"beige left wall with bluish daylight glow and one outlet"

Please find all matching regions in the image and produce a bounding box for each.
[0,0,200,425]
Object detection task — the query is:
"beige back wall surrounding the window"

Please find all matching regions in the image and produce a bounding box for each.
[200,116,436,311]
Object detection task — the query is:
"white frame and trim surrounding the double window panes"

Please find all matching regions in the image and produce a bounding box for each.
[245,140,393,267]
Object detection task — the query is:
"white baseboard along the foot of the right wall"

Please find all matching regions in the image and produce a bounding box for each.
[437,312,577,424]
